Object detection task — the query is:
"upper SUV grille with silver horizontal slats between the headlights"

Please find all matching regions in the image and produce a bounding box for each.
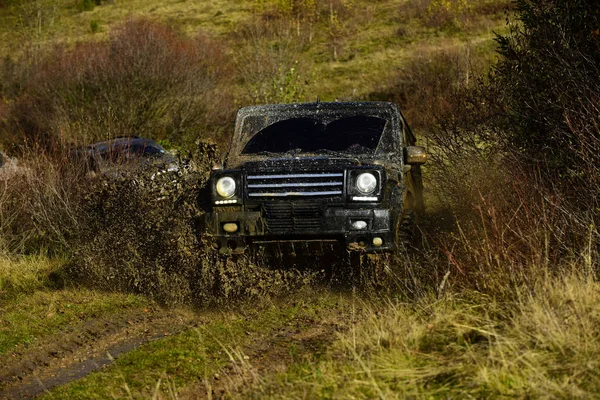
[247,171,344,198]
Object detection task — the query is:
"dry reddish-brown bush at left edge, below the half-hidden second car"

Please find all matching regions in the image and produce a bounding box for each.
[0,150,86,255]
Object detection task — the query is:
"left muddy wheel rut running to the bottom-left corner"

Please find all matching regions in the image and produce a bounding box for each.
[0,309,198,399]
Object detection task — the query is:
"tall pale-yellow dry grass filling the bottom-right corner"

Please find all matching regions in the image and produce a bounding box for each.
[254,270,600,399]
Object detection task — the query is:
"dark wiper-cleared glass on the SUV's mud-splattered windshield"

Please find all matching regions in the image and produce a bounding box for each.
[242,115,387,154]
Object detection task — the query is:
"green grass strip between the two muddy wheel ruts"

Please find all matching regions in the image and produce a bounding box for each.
[45,292,358,399]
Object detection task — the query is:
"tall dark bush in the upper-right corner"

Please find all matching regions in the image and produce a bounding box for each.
[493,0,600,202]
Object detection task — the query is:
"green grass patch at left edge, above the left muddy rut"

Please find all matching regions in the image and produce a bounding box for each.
[0,255,150,355]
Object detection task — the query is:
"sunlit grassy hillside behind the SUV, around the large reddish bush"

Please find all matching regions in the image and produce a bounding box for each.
[0,0,507,149]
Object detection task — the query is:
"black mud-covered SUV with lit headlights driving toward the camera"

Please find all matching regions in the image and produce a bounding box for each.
[205,102,426,253]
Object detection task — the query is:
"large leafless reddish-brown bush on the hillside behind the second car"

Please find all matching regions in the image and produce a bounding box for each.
[4,20,233,153]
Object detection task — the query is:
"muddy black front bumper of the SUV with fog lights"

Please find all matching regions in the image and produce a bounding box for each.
[204,207,396,253]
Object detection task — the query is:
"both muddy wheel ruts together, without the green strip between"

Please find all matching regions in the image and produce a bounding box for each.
[0,297,349,399]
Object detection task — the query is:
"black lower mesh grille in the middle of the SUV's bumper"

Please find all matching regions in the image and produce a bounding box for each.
[263,201,322,234]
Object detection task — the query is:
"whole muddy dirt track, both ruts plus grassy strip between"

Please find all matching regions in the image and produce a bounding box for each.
[0,294,351,399]
